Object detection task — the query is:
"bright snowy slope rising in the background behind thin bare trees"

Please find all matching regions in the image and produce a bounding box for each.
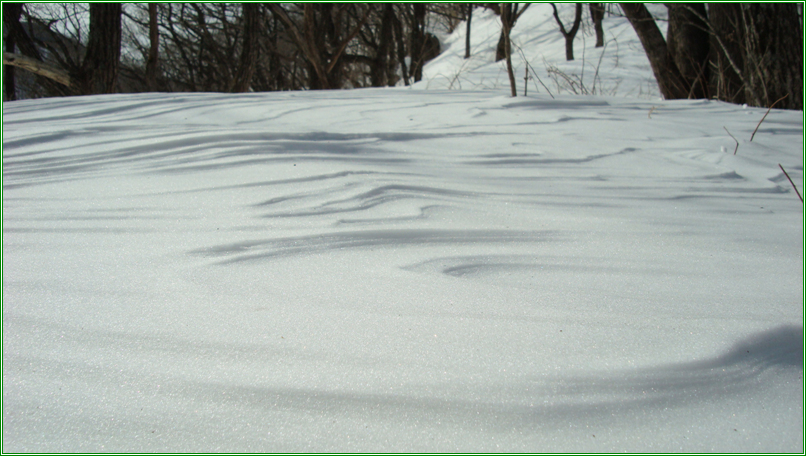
[415,3,666,99]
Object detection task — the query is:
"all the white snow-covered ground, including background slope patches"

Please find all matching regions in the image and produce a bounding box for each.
[3,5,803,452]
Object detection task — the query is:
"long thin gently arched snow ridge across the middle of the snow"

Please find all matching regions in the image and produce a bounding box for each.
[189,229,559,264]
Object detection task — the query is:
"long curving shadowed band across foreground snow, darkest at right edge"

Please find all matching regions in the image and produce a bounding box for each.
[6,317,803,444]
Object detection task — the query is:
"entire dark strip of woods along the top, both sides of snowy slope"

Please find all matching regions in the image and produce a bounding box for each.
[3,3,803,109]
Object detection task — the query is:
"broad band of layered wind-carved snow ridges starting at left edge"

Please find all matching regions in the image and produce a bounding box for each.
[3,127,436,183]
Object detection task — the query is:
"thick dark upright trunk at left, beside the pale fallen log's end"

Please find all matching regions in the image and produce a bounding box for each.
[76,3,122,95]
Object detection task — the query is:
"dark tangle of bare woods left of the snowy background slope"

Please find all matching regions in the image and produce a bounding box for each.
[3,3,448,99]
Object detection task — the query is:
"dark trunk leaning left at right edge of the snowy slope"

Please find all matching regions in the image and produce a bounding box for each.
[619,3,689,100]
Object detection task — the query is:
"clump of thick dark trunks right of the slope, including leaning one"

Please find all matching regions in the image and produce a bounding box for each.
[621,3,803,109]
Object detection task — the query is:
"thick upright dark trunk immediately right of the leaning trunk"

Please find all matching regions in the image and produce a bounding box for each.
[666,3,710,98]
